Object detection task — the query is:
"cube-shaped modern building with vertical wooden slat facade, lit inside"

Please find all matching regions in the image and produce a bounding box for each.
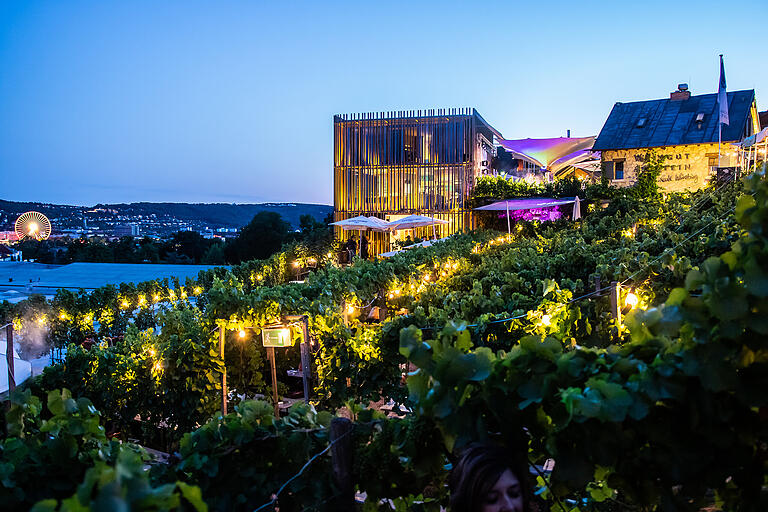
[334,108,502,254]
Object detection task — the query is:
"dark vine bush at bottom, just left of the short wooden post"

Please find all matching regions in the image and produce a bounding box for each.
[175,401,332,511]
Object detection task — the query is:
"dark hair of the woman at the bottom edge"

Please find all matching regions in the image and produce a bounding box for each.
[448,443,530,512]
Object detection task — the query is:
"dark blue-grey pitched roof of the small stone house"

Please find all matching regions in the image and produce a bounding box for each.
[592,89,755,151]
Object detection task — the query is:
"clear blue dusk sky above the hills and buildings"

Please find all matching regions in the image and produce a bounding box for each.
[0,0,768,205]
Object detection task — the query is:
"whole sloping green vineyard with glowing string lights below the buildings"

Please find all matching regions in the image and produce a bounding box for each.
[0,167,768,512]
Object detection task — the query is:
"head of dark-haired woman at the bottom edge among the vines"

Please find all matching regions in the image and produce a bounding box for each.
[449,444,529,512]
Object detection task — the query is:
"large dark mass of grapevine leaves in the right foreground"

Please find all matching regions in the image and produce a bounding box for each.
[401,170,768,511]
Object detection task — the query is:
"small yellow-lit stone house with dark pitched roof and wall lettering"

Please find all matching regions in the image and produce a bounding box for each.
[592,84,760,192]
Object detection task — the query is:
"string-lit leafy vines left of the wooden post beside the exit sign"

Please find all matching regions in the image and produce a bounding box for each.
[28,310,222,449]
